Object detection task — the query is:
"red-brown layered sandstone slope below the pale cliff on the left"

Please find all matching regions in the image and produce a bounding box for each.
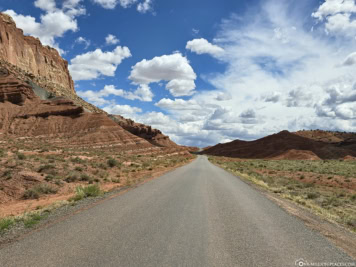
[0,69,153,150]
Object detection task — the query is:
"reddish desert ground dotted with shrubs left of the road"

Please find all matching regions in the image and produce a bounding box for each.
[0,139,193,236]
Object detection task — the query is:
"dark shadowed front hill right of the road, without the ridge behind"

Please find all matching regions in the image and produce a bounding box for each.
[203,131,356,160]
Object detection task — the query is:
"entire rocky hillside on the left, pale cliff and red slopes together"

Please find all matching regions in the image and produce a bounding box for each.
[0,13,184,153]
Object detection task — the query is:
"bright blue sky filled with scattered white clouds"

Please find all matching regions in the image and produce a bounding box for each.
[0,0,356,146]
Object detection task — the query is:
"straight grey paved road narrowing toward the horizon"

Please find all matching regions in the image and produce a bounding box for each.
[0,156,353,267]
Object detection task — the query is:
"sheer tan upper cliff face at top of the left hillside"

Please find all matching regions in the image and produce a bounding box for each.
[0,13,74,96]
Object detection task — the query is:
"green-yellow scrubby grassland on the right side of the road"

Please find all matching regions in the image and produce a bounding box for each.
[209,157,356,232]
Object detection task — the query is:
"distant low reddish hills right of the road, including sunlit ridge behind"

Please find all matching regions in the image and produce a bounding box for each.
[202,130,356,160]
